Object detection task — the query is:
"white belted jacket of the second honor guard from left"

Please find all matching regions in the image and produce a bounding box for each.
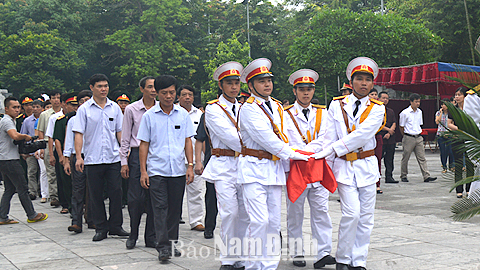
[237,95,293,185]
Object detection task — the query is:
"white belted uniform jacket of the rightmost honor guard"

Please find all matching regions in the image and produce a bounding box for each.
[323,94,385,187]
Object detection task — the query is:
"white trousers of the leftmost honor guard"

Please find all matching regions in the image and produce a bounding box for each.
[215,178,249,267]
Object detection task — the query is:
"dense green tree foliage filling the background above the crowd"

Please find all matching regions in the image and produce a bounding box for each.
[0,0,480,104]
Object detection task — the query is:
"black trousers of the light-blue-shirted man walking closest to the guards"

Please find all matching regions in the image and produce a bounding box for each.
[148,175,186,252]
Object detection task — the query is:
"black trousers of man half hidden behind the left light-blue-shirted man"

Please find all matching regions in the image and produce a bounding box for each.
[70,155,93,227]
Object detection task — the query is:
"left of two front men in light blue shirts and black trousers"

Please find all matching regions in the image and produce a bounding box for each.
[73,74,129,241]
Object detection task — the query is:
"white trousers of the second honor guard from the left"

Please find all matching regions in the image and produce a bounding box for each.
[242,182,282,270]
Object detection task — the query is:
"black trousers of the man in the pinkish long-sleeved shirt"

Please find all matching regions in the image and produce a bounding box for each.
[127,148,156,244]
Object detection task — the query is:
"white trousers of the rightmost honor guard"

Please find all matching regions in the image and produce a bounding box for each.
[336,180,376,267]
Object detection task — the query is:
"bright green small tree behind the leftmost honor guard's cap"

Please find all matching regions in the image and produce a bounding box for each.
[202,35,251,101]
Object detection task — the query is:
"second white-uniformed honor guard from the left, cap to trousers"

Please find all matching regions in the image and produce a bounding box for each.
[237,58,308,269]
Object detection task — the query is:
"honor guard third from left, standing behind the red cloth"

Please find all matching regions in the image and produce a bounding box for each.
[285,69,335,269]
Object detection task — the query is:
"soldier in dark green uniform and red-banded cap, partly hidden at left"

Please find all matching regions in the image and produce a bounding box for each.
[52,93,78,211]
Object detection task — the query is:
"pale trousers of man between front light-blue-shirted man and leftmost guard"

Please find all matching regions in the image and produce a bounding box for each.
[185,170,205,229]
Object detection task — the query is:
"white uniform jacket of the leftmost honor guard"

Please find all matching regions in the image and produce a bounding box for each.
[202,95,242,181]
